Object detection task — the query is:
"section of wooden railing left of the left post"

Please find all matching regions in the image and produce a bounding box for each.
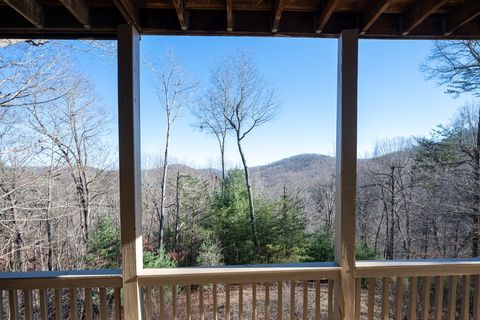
[0,270,122,320]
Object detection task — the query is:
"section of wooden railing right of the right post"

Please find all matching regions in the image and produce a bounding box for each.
[355,259,480,320]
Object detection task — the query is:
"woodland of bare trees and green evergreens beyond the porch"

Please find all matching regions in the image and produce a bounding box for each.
[0,41,480,271]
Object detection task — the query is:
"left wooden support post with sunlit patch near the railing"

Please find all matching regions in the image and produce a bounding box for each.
[118,25,143,319]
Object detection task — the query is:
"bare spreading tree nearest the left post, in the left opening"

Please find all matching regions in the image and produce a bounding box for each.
[29,80,109,243]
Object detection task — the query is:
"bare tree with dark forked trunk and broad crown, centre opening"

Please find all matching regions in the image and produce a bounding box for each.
[210,52,280,251]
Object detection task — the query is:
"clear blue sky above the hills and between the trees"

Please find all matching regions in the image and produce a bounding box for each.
[79,36,473,167]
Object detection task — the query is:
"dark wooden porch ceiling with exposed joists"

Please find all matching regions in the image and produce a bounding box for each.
[0,0,480,39]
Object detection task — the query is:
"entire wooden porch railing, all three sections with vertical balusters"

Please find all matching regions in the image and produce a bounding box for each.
[0,259,480,320]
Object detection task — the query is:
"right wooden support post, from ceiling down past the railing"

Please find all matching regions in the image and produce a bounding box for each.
[335,29,358,319]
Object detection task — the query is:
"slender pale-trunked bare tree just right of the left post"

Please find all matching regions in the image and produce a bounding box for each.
[147,52,197,247]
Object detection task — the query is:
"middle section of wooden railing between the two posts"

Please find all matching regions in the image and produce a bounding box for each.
[138,263,340,320]
